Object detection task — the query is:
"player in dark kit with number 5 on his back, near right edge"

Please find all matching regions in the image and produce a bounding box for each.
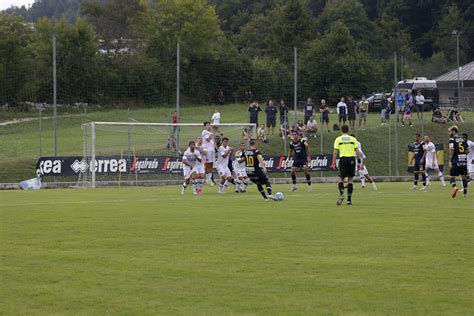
[448,126,469,198]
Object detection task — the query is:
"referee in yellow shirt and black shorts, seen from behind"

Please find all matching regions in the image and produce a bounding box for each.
[331,125,360,205]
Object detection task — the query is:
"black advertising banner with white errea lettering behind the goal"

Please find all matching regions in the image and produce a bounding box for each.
[36,155,332,177]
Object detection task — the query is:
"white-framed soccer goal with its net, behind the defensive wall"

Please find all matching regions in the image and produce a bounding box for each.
[78,122,256,188]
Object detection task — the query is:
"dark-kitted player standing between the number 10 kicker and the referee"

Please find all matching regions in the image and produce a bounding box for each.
[288,132,312,192]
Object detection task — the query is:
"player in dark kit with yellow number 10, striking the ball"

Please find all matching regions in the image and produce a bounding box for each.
[241,139,275,201]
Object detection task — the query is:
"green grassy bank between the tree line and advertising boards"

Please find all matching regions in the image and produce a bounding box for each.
[0,105,474,182]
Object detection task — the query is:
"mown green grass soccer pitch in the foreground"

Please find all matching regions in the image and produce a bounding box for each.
[0,183,474,315]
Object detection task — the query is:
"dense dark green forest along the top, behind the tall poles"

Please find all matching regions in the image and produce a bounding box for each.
[0,0,474,106]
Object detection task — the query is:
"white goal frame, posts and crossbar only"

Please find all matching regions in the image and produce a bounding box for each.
[82,121,257,188]
